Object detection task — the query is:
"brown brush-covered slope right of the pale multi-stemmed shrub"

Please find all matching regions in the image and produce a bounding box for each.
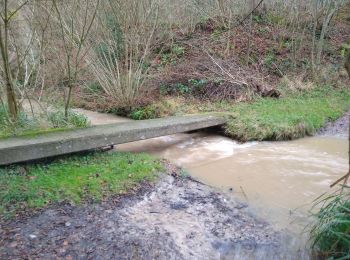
[70,0,350,114]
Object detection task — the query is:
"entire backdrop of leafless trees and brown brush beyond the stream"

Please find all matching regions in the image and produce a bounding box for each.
[0,0,350,119]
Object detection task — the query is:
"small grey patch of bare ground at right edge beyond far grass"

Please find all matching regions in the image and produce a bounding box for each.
[318,111,350,136]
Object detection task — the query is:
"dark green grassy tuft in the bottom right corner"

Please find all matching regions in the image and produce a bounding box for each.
[310,186,350,259]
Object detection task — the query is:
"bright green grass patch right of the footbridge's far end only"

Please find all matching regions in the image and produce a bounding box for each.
[226,88,350,141]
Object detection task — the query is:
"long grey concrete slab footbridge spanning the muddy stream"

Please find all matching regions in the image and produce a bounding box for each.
[0,114,226,165]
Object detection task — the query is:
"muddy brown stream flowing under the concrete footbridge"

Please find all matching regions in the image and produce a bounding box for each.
[75,110,348,256]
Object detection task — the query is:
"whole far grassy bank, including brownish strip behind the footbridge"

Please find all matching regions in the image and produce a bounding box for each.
[129,87,350,141]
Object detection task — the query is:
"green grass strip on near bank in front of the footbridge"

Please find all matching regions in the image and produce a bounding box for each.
[0,152,162,217]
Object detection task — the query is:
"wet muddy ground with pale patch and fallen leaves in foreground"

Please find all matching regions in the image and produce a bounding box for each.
[0,166,297,259]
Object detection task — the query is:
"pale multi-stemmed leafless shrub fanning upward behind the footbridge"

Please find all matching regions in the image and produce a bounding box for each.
[89,0,159,106]
